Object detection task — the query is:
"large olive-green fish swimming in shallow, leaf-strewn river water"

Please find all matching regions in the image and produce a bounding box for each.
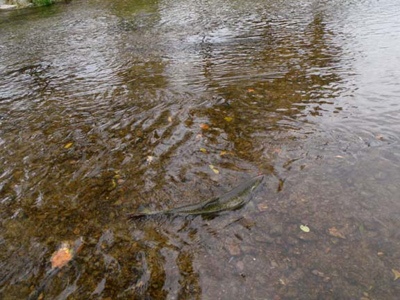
[128,175,264,218]
